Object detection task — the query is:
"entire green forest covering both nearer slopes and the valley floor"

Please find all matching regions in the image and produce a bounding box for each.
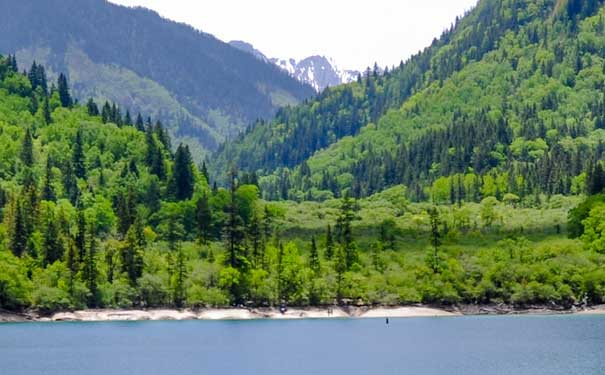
[0,0,605,313]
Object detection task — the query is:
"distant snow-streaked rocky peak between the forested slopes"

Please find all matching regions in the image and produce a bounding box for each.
[229,40,359,92]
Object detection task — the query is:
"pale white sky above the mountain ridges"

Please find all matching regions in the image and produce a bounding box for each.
[110,0,477,70]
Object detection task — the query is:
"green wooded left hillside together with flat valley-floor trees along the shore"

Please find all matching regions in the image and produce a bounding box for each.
[0,56,605,313]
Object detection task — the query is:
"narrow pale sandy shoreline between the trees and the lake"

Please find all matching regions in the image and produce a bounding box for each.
[0,305,605,323]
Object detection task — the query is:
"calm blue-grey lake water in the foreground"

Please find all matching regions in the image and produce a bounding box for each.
[0,316,605,375]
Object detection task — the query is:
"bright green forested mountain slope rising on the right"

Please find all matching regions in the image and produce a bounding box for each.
[215,0,605,202]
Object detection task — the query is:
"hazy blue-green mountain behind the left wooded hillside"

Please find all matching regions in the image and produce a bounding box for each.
[0,0,313,157]
